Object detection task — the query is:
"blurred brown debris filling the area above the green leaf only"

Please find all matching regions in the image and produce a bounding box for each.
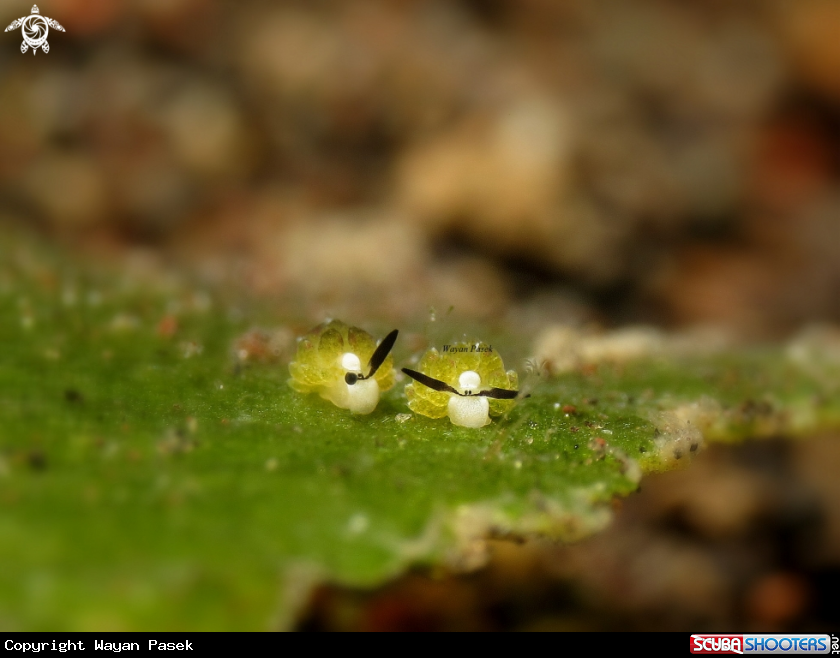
[0,0,840,333]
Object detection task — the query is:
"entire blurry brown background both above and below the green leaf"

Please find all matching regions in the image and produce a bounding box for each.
[0,0,840,630]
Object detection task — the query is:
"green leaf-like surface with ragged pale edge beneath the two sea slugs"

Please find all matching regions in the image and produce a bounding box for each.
[0,229,840,630]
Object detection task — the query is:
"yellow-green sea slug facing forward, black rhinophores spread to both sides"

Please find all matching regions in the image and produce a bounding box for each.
[402,342,519,427]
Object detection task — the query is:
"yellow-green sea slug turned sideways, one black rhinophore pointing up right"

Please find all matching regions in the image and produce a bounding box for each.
[289,320,398,414]
